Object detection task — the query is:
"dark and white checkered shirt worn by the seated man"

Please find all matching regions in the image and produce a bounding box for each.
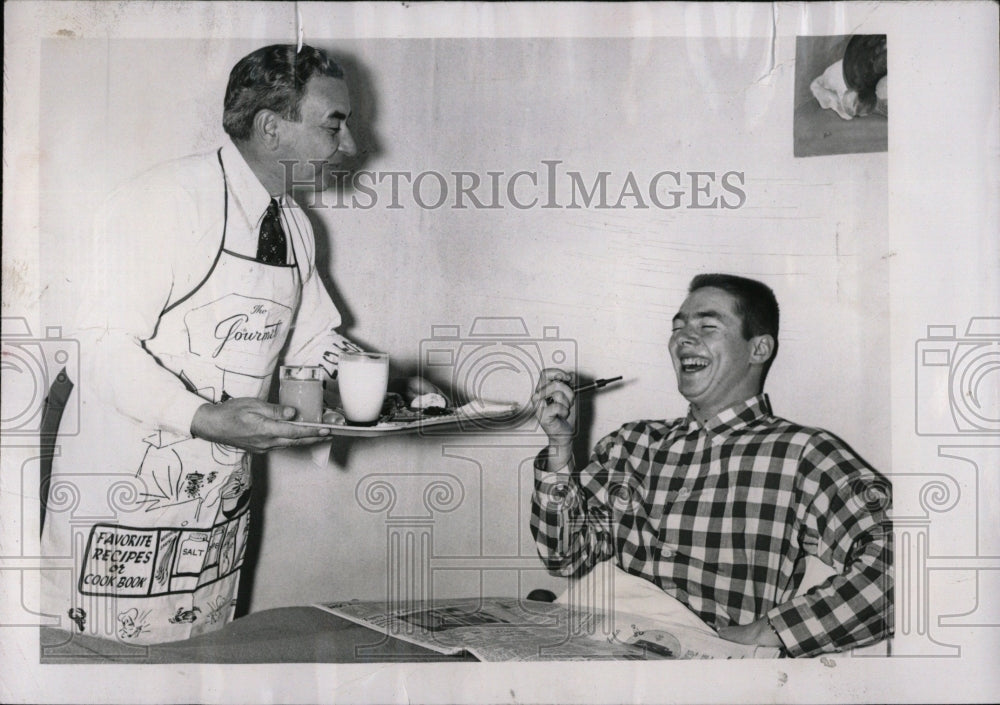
[531,395,893,656]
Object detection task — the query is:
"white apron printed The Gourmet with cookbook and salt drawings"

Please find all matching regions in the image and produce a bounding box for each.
[42,152,301,644]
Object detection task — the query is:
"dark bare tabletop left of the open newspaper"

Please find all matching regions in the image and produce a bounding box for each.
[40,607,476,664]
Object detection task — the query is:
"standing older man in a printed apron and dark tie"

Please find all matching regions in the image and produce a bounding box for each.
[42,45,386,644]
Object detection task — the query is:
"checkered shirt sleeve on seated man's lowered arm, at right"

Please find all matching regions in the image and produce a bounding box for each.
[767,433,893,656]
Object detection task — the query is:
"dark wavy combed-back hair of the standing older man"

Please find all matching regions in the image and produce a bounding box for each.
[222,44,344,141]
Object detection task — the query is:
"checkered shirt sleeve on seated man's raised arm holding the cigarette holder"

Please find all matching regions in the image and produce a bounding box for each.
[531,434,616,577]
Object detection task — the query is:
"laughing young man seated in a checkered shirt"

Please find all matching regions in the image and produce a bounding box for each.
[531,274,893,656]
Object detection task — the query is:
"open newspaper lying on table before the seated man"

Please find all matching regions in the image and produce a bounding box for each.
[316,597,779,661]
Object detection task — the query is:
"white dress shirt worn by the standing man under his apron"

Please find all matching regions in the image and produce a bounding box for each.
[74,140,354,435]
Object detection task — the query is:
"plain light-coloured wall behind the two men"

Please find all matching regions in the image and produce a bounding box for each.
[39,29,890,610]
